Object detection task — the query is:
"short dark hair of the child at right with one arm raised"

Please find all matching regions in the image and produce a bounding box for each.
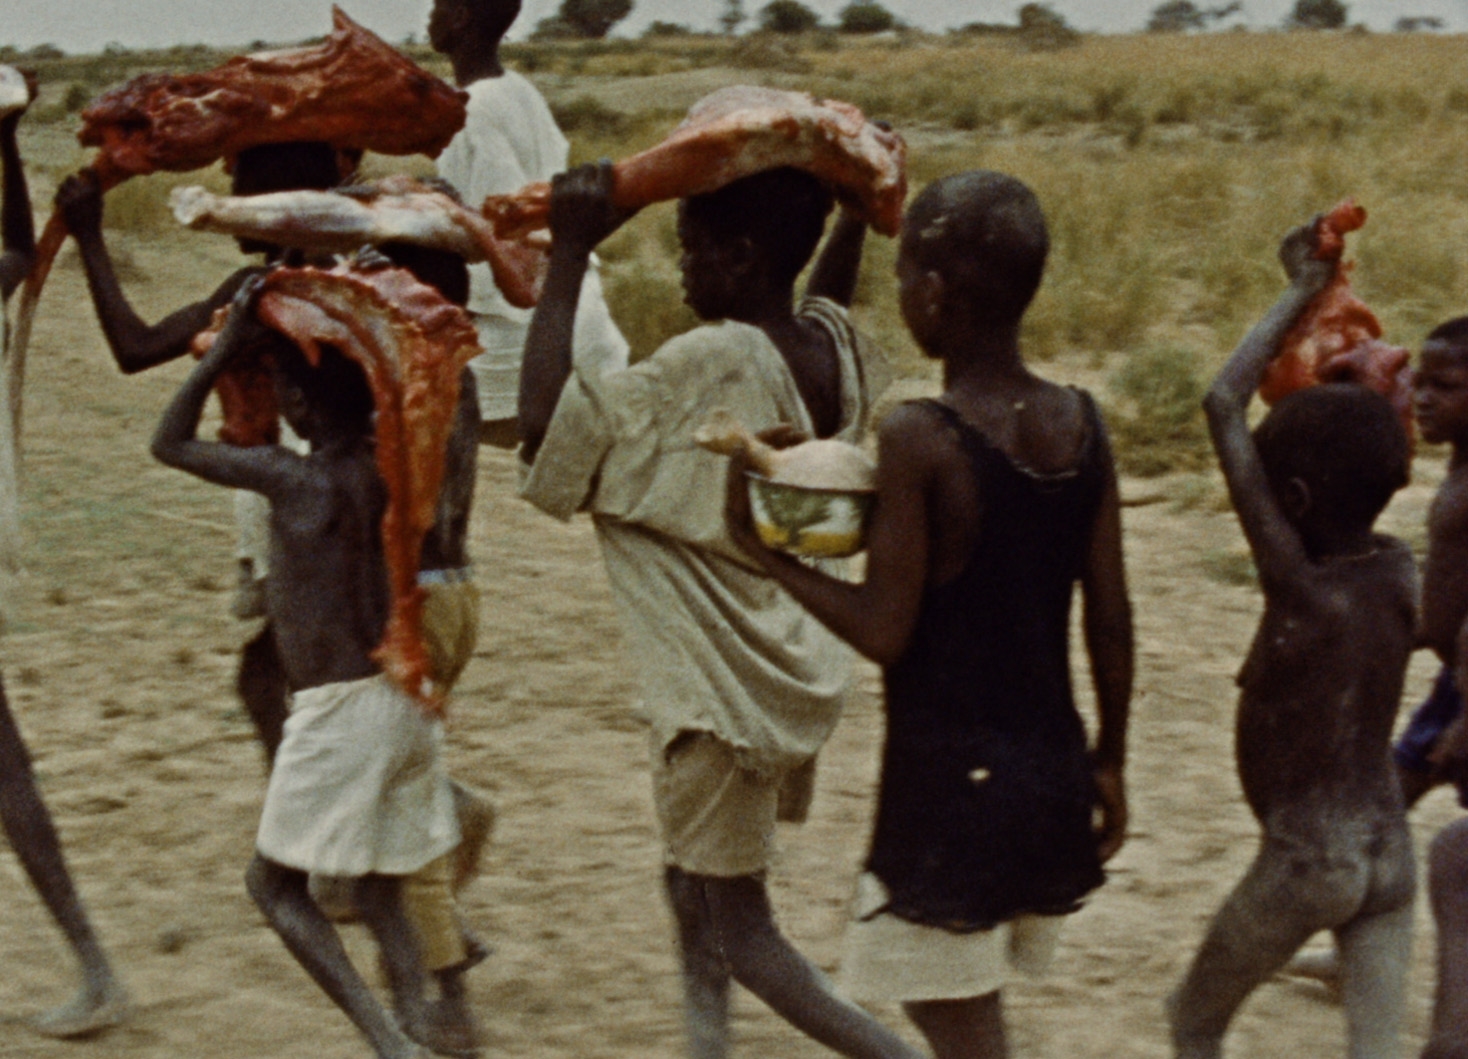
[1254,382,1411,526]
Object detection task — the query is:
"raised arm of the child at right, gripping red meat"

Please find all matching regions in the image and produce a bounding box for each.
[1202,225,1336,586]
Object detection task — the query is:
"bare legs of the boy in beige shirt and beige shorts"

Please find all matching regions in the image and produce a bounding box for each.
[668,868,922,1059]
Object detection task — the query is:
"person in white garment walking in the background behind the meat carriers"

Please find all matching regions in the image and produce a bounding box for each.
[429,0,627,448]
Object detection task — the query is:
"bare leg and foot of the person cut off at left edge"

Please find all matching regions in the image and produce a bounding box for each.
[0,683,128,1037]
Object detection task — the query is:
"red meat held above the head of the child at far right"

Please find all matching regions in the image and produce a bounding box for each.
[1260,198,1412,433]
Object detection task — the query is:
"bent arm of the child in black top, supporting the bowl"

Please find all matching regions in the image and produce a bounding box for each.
[725,407,935,665]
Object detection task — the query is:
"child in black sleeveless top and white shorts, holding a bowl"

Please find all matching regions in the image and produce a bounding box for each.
[728,170,1132,1059]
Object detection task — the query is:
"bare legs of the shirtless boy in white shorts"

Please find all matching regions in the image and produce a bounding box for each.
[245,853,424,1059]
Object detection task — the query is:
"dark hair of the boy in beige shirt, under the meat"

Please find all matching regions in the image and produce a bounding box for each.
[683,166,834,283]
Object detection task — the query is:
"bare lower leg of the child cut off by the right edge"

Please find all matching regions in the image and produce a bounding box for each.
[1422,820,1468,1059]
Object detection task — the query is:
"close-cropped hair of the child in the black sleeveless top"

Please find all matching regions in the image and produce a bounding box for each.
[903,169,1050,325]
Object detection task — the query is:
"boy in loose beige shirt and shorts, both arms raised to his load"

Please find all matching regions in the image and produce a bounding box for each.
[520,166,918,1059]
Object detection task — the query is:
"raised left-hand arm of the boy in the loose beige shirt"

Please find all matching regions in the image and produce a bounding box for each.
[520,162,634,463]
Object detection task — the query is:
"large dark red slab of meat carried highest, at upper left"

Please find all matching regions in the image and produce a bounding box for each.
[78,7,467,175]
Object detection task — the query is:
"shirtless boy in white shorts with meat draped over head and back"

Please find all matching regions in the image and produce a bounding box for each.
[153,279,459,1059]
